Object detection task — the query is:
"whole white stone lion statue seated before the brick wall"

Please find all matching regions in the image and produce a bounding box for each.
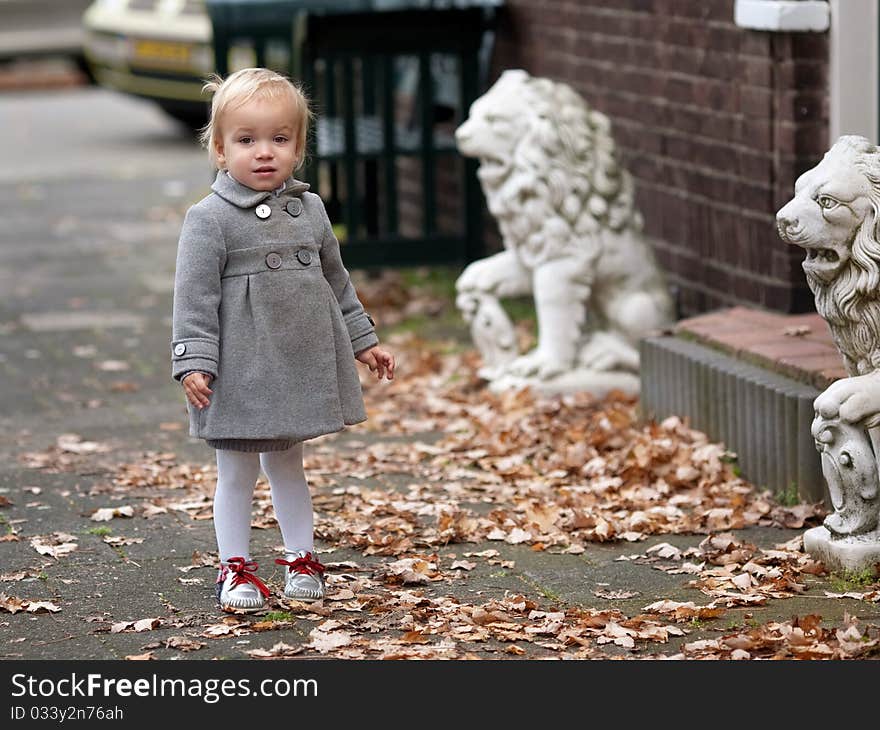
[455,70,673,392]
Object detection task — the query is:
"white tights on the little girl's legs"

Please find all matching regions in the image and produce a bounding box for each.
[214,443,314,561]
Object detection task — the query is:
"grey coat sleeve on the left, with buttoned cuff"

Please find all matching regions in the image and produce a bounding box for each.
[171,206,226,380]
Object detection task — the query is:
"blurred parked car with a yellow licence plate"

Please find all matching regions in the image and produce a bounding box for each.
[82,0,214,128]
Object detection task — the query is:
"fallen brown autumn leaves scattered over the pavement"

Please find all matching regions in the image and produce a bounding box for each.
[6,272,880,659]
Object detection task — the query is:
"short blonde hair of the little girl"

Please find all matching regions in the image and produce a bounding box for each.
[199,68,314,170]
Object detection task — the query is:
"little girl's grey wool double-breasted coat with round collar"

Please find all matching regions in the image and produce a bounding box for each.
[171,171,378,451]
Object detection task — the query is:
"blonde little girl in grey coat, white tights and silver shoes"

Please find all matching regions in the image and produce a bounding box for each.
[171,68,394,612]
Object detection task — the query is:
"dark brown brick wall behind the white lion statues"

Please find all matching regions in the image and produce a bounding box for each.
[494,0,828,315]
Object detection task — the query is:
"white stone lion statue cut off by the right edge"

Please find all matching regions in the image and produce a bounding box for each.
[776,136,880,562]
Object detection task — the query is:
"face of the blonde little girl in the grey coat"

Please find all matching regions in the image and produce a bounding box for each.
[216,99,299,190]
